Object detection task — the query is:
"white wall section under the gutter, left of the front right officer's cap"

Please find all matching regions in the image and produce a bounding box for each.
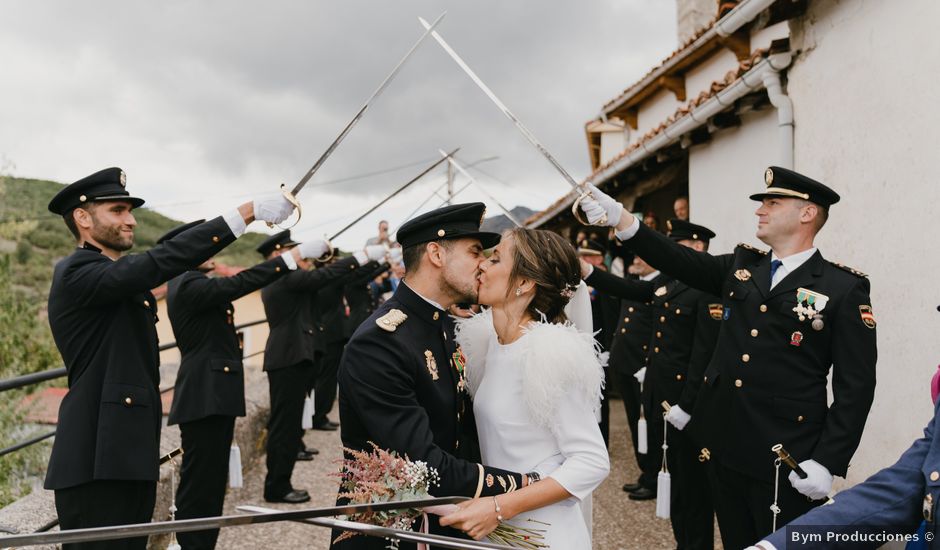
[689,109,777,254]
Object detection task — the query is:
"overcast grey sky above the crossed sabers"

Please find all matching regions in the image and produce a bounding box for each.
[0,0,676,248]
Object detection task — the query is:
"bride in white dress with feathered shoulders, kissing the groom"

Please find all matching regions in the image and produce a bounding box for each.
[441,228,610,549]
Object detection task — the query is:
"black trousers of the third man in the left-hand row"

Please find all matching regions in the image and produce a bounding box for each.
[264,361,314,499]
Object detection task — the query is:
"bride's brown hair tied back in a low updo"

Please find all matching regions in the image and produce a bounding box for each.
[505,227,581,323]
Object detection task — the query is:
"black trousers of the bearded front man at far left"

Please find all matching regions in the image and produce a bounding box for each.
[55,479,157,550]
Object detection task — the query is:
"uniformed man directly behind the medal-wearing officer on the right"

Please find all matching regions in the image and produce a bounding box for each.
[589,219,723,549]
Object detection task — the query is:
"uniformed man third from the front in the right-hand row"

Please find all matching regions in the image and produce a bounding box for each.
[581,254,671,500]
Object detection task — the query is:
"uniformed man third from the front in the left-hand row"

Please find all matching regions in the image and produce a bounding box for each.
[258,230,386,503]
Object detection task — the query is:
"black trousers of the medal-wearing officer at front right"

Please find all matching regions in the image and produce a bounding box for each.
[709,459,826,548]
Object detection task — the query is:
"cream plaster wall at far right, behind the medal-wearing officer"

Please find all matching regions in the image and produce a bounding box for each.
[788,0,940,483]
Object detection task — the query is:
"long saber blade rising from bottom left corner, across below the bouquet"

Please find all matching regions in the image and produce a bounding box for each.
[0,497,470,548]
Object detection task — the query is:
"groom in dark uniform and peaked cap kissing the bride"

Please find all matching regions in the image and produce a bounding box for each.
[332,203,528,550]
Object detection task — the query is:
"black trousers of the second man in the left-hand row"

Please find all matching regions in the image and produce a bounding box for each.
[176,416,235,550]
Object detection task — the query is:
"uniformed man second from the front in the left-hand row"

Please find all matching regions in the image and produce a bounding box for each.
[157,220,328,550]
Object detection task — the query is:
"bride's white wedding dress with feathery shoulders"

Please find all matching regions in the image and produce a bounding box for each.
[457,312,610,550]
